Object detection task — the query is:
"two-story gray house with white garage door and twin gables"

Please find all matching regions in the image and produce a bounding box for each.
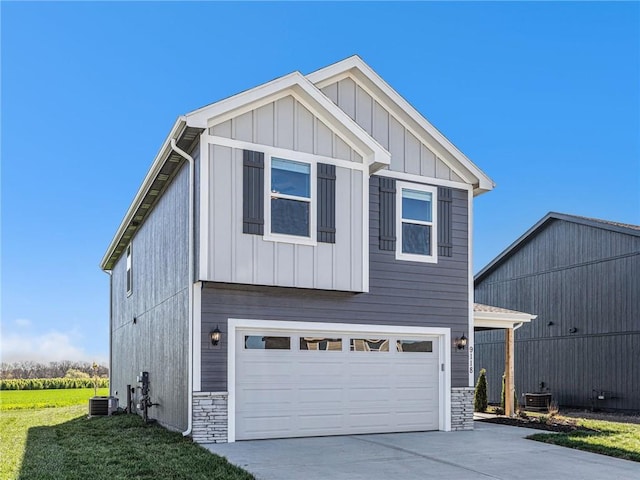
[101,56,493,442]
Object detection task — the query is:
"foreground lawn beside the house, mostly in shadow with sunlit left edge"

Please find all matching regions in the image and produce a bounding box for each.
[0,390,253,480]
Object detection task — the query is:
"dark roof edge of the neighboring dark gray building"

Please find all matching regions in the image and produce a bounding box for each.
[474,212,640,285]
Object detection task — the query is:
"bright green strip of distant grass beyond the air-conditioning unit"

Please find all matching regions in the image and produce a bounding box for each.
[0,388,109,411]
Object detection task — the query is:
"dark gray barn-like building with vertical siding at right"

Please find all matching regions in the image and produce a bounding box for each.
[474,212,640,410]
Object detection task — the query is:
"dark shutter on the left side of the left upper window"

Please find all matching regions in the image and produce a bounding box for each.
[242,150,264,235]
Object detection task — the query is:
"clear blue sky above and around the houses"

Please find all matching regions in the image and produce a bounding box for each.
[0,2,640,361]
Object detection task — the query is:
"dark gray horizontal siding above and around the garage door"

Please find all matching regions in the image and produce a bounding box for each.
[201,176,469,391]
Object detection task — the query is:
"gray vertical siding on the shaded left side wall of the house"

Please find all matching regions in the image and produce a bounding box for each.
[110,162,189,430]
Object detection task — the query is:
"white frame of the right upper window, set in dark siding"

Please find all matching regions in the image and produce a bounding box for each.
[396,182,438,263]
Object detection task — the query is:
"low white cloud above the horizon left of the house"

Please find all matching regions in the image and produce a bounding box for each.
[0,331,105,363]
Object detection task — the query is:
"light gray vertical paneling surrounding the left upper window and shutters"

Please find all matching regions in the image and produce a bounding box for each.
[199,97,364,291]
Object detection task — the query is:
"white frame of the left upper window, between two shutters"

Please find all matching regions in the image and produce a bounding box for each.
[263,153,318,246]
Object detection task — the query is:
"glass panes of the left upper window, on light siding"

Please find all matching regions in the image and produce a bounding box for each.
[269,157,312,237]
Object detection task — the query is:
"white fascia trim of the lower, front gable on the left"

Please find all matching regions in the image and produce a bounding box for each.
[186,72,391,171]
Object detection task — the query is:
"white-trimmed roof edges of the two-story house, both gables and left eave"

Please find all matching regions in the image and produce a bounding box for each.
[100,56,494,271]
